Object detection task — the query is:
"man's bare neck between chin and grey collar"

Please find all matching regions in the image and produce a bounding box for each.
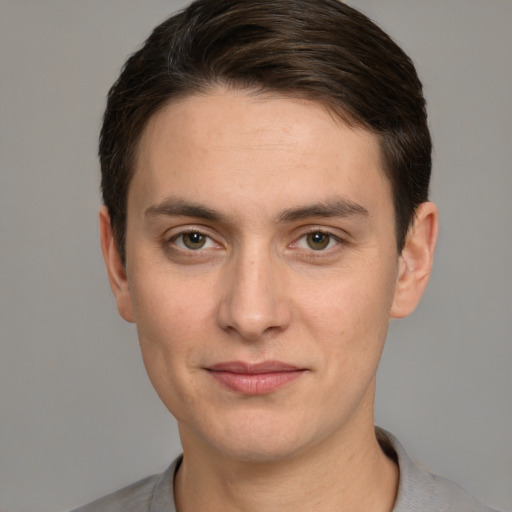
[175,416,398,512]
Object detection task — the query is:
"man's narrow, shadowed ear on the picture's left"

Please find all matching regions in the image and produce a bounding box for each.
[99,206,134,322]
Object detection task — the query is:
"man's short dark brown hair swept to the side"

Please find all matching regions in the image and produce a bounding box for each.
[99,0,432,262]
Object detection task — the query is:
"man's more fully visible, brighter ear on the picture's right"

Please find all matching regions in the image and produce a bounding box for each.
[391,202,438,318]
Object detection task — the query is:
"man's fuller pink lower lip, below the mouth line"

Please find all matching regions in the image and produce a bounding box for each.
[210,370,304,395]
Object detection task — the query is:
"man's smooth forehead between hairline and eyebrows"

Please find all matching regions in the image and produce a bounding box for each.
[129,89,391,220]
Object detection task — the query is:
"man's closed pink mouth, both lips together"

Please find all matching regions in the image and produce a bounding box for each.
[206,361,307,395]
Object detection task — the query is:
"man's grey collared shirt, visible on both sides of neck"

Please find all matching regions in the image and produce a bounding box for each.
[73,429,497,512]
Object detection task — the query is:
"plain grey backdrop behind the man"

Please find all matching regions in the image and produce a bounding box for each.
[0,0,512,512]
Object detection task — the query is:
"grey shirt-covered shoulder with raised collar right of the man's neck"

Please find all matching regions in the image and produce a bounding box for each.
[377,429,504,512]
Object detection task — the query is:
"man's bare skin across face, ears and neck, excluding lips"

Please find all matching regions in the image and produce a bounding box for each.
[100,89,437,512]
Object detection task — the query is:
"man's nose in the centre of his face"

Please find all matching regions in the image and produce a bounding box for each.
[218,247,291,341]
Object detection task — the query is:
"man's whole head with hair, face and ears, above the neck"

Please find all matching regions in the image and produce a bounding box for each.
[100,0,437,461]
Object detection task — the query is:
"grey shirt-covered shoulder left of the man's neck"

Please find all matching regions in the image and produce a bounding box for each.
[68,458,180,512]
